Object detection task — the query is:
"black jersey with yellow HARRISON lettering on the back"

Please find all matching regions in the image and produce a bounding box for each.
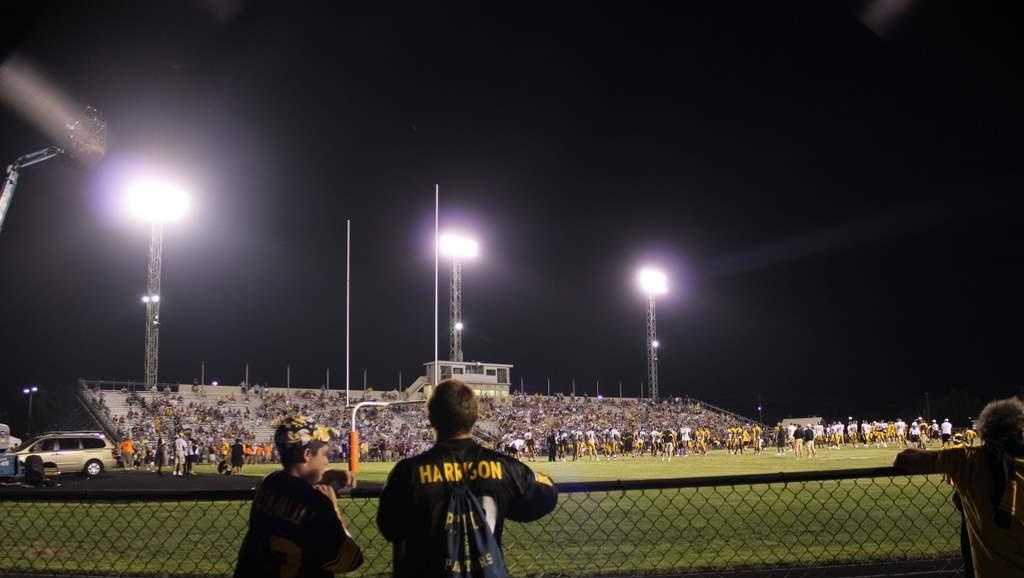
[377,439,558,578]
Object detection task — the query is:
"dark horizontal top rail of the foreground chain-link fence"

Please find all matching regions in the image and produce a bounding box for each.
[0,467,913,501]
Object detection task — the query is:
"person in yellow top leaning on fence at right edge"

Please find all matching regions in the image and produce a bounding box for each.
[895,398,1024,578]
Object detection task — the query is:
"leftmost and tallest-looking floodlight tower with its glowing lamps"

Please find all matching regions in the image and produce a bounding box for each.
[125,178,189,386]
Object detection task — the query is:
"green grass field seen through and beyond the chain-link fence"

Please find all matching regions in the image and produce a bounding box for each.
[0,449,958,576]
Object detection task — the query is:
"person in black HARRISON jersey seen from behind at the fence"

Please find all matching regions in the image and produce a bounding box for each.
[377,379,558,578]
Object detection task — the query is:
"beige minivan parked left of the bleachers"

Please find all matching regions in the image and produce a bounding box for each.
[14,431,117,478]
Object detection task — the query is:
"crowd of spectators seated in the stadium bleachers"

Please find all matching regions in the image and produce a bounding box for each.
[81,386,746,460]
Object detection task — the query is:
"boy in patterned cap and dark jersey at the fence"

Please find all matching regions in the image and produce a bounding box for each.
[234,416,362,578]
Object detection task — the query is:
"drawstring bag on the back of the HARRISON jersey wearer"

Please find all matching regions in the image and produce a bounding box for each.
[441,454,508,578]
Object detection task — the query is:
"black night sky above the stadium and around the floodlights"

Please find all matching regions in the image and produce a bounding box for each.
[0,0,1024,422]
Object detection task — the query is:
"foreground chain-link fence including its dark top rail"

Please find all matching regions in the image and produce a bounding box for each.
[0,468,963,578]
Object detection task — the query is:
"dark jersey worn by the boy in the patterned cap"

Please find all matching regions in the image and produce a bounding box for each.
[234,470,362,578]
